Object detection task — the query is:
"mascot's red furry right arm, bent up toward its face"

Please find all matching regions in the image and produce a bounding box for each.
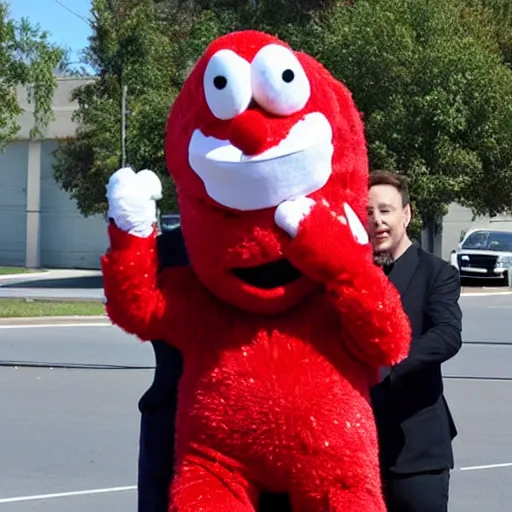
[287,206,411,367]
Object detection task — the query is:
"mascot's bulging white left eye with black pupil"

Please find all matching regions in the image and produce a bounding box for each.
[203,50,252,120]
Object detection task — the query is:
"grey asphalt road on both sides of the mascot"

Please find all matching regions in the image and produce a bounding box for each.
[0,296,512,512]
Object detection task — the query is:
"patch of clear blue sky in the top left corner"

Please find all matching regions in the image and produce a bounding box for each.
[7,0,91,67]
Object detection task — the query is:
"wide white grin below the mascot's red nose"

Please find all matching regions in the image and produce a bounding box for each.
[188,112,334,211]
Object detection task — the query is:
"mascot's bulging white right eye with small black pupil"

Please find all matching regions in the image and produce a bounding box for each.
[251,44,311,116]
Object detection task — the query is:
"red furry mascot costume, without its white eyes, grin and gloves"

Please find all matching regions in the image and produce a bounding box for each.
[103,33,410,512]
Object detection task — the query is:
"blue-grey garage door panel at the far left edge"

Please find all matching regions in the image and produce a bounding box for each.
[0,141,28,266]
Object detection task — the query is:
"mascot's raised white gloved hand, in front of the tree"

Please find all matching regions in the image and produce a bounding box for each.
[107,167,162,237]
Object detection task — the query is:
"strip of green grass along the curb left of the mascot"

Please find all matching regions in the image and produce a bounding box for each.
[0,299,105,318]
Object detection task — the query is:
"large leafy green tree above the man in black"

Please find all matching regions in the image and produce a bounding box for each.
[321,0,512,221]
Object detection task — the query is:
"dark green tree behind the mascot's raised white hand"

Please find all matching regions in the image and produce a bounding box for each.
[55,0,182,215]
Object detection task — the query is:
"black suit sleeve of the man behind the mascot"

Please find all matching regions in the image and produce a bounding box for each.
[389,264,462,384]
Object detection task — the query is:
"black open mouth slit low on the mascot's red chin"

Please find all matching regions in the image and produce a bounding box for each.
[232,259,302,290]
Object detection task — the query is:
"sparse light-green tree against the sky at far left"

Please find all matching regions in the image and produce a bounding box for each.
[0,0,64,150]
